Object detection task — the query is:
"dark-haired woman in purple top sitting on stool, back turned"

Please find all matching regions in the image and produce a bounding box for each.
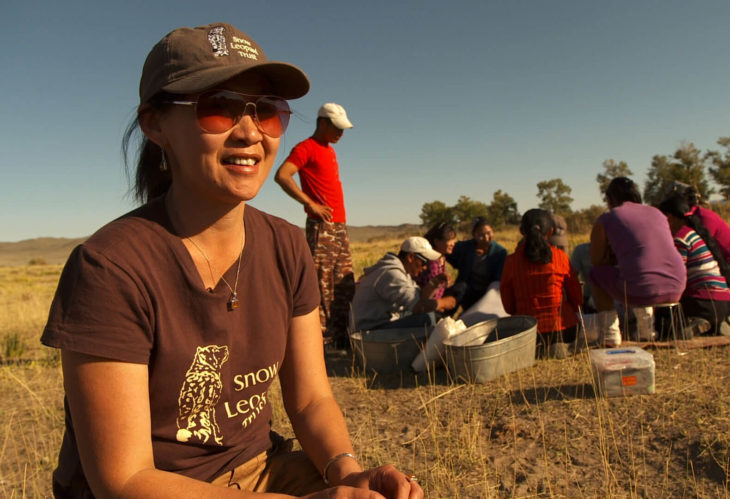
[590,177,686,347]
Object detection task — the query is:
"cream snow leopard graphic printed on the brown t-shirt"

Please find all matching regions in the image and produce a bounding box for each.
[176,345,228,445]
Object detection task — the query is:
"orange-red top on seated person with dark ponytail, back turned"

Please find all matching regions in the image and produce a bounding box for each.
[499,244,583,333]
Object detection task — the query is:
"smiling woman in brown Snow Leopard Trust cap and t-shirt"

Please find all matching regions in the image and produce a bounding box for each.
[42,23,423,498]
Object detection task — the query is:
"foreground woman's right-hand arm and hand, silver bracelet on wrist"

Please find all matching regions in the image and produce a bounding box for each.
[279,309,423,499]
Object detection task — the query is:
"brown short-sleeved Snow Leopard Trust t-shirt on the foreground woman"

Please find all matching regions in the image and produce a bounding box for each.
[41,199,319,487]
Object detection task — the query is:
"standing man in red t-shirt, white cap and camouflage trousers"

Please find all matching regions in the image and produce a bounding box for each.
[275,102,355,348]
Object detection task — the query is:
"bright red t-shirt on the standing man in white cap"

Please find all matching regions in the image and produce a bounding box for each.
[286,137,347,223]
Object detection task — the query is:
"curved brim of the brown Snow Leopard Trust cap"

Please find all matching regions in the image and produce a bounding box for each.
[162,61,309,99]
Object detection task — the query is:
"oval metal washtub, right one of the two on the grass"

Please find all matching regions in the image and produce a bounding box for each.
[444,315,537,383]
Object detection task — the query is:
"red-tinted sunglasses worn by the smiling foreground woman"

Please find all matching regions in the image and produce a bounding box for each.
[166,90,292,138]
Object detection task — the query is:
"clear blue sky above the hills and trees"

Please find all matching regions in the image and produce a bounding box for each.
[0,0,730,241]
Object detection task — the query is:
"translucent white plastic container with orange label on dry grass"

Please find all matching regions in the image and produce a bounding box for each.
[589,347,655,397]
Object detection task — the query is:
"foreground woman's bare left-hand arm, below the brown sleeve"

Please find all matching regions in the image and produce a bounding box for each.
[62,351,288,498]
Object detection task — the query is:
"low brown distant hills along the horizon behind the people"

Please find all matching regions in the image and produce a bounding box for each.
[0,224,423,267]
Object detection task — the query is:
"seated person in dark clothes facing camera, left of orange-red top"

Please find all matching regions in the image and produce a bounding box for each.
[445,217,507,310]
